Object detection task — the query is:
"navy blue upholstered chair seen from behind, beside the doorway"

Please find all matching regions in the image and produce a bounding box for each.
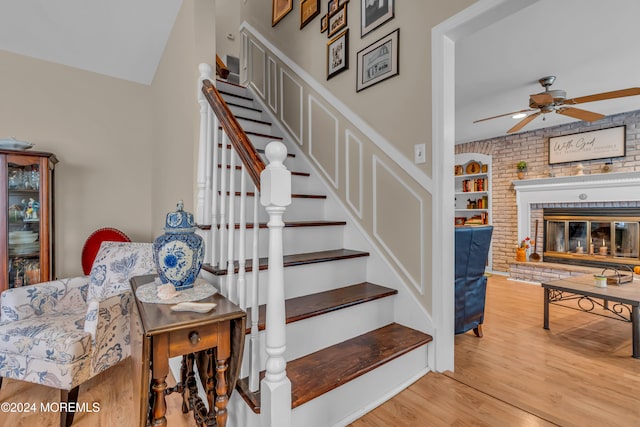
[455,225,493,337]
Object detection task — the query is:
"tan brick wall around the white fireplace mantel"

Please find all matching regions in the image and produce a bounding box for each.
[455,110,640,272]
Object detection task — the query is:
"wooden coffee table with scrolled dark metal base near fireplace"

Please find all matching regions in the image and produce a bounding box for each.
[542,275,640,359]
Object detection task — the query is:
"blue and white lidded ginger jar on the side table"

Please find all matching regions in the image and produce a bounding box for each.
[153,201,204,291]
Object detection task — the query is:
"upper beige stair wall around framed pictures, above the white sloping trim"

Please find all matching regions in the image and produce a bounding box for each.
[242,0,473,174]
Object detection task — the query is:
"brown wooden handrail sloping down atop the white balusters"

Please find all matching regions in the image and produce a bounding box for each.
[202,79,265,190]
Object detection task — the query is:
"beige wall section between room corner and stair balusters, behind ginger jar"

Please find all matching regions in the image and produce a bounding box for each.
[149,0,216,236]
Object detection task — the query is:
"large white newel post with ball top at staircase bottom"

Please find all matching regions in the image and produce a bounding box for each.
[254,141,291,427]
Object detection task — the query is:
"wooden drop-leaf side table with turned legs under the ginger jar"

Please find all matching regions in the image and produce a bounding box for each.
[131,275,246,427]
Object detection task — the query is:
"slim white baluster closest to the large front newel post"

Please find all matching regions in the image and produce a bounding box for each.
[249,185,260,392]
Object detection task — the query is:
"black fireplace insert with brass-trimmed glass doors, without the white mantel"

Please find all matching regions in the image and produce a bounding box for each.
[542,207,640,266]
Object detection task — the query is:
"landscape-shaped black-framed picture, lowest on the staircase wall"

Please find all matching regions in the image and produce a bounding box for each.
[356,29,400,92]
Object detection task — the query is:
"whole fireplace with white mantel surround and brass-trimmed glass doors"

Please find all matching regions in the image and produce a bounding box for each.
[513,172,640,267]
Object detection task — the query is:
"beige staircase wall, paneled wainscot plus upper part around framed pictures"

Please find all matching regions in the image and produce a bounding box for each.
[242,0,472,310]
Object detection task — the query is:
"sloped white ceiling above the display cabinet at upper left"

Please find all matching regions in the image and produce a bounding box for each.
[0,0,182,84]
